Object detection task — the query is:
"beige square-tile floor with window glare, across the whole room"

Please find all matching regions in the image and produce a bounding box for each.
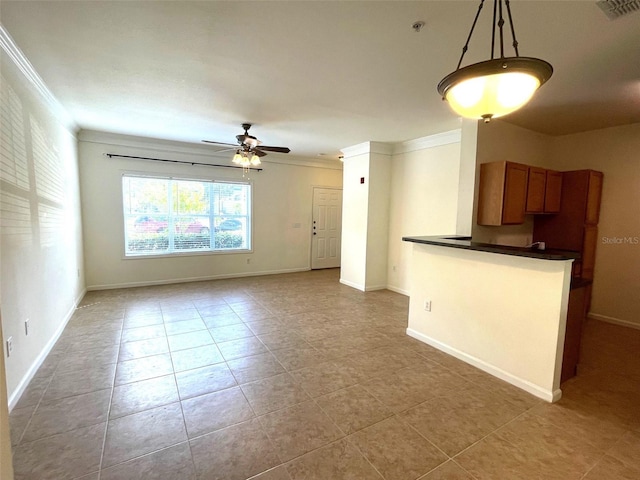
[11,270,640,480]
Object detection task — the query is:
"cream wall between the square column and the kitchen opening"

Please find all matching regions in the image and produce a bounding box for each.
[387,131,461,295]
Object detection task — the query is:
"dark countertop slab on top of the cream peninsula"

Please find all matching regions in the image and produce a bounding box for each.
[402,235,580,260]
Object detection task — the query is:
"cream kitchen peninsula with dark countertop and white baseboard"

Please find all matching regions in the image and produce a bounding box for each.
[403,236,580,402]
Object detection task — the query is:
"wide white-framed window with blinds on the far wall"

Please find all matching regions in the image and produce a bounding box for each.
[122,175,251,257]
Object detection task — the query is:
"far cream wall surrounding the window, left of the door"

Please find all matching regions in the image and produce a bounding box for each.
[79,131,342,289]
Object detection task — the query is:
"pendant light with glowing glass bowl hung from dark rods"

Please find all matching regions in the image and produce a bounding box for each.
[438,0,553,123]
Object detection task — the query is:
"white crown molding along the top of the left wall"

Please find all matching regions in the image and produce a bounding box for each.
[0,24,79,134]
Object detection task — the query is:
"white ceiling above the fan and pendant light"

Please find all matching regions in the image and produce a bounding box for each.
[0,0,640,157]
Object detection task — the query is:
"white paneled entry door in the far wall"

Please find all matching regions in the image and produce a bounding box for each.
[311,188,342,269]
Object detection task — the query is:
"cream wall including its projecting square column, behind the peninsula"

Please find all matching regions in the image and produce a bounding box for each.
[340,133,464,295]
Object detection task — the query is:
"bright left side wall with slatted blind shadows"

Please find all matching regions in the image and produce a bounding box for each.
[0,47,84,406]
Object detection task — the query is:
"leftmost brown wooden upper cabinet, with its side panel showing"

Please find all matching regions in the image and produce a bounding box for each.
[478,162,529,225]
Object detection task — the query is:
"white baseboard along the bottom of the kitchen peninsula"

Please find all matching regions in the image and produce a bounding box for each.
[407,328,562,403]
